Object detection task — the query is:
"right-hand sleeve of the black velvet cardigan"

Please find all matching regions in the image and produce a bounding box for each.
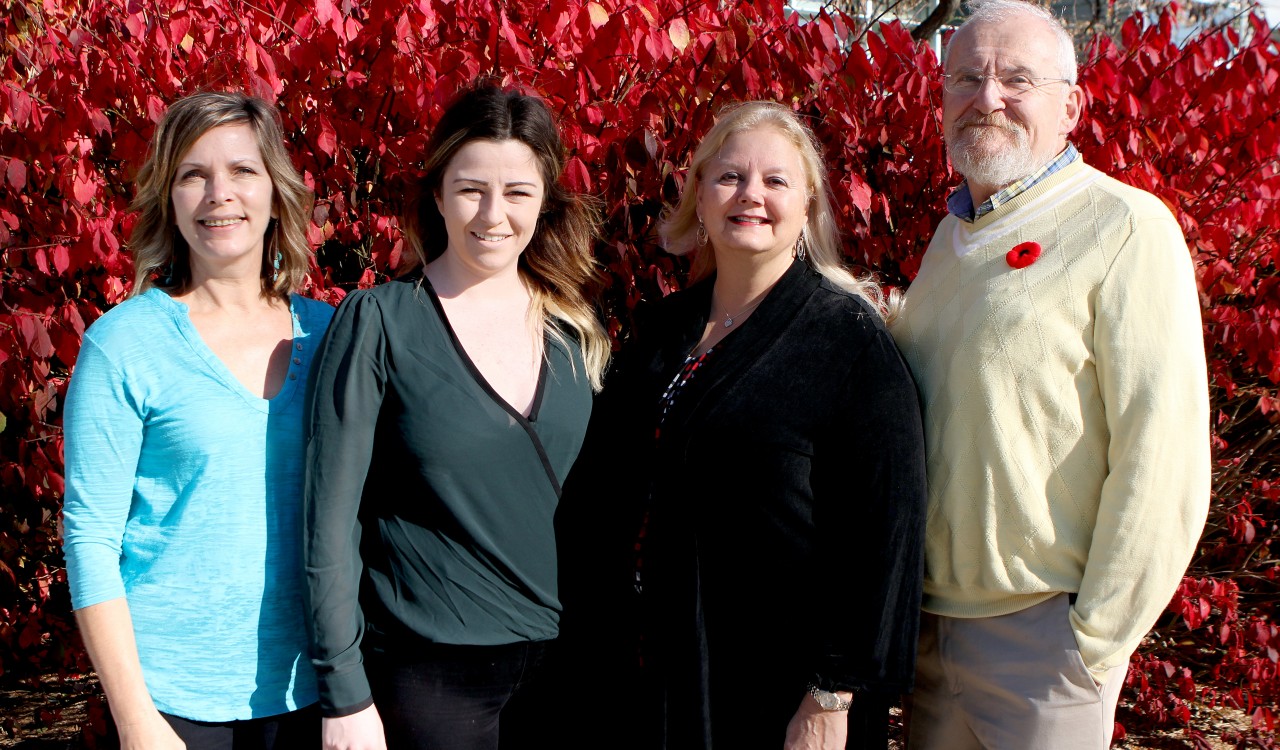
[814,323,927,695]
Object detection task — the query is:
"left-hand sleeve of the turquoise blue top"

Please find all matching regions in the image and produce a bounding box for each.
[63,331,142,609]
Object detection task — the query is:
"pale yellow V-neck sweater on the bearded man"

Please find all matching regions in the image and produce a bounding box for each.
[893,160,1210,673]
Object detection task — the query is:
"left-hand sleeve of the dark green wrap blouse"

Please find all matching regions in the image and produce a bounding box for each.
[302,292,387,717]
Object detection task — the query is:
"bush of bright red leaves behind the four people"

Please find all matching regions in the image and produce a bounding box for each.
[0,0,1280,744]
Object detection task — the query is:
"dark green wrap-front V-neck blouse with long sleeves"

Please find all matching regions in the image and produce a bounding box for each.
[303,275,591,715]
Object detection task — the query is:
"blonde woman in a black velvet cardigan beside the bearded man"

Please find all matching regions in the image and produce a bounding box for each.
[561,102,925,750]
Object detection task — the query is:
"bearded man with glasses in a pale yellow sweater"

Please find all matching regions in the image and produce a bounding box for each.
[893,0,1210,750]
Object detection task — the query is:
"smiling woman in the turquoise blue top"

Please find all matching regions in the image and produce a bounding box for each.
[64,92,333,749]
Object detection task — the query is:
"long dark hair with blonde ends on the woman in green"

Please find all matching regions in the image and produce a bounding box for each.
[402,84,612,390]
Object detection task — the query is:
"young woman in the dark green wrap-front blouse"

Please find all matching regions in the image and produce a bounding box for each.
[303,86,609,749]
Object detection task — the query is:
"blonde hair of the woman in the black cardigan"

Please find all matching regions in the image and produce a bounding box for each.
[659,101,893,317]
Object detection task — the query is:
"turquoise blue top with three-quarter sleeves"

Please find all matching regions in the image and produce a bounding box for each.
[63,284,333,722]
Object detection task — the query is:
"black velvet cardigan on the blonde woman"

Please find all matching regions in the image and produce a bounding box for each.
[558,261,925,750]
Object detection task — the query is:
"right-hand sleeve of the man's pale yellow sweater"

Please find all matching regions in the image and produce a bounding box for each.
[1071,207,1210,673]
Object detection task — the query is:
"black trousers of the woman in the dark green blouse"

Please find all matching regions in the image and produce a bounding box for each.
[365,639,556,750]
